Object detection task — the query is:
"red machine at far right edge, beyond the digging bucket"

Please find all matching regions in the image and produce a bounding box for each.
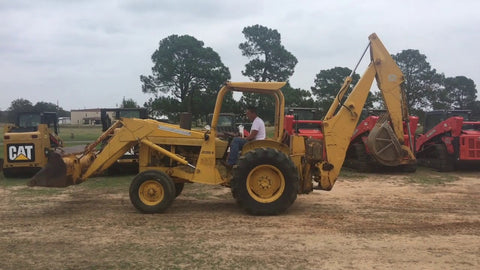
[415,110,480,172]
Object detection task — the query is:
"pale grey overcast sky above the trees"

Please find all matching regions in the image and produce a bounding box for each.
[0,0,480,110]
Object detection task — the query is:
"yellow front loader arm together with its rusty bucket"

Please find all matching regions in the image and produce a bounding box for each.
[29,118,204,187]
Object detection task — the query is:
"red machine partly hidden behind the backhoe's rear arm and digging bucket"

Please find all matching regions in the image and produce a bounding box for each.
[344,110,418,172]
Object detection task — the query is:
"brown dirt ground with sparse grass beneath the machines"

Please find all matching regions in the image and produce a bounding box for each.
[0,172,480,269]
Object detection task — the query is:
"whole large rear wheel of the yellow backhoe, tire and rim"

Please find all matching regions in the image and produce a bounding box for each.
[231,148,299,215]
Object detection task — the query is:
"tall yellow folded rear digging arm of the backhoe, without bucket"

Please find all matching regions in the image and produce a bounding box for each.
[316,34,415,190]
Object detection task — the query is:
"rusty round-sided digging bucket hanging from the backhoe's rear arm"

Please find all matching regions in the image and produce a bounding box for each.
[367,116,405,166]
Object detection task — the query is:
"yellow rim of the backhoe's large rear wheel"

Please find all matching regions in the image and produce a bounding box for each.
[247,165,285,203]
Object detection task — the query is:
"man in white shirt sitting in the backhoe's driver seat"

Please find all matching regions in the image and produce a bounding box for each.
[227,107,266,166]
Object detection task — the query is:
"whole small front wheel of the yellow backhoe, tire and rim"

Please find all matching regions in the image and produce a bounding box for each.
[129,170,176,214]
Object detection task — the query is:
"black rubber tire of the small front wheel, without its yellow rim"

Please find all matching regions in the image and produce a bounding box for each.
[129,170,176,214]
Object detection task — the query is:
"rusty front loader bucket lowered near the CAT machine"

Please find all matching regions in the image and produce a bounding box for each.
[28,152,73,187]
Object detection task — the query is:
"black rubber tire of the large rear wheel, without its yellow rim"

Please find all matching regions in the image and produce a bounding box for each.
[231,148,299,215]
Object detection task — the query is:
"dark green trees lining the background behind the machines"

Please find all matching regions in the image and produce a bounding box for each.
[4,24,480,121]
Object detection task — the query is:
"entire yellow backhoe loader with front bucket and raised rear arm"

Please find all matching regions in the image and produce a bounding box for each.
[29,34,415,215]
